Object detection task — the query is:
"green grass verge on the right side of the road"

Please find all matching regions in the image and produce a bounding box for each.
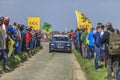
[73,49,107,80]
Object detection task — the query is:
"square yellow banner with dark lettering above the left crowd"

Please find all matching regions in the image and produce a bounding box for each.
[28,17,40,30]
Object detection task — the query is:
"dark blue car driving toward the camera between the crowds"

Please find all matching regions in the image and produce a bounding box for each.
[49,35,72,53]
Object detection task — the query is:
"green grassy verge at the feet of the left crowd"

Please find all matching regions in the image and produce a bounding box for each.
[0,46,43,72]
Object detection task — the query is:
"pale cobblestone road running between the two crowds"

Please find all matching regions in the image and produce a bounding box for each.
[0,43,85,80]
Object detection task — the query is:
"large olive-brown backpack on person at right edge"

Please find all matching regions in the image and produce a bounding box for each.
[108,31,120,55]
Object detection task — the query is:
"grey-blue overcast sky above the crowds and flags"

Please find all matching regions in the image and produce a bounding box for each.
[0,0,120,31]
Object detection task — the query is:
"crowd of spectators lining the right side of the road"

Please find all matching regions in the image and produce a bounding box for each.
[68,22,120,80]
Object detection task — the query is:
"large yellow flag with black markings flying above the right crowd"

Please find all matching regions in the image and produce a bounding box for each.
[75,11,92,32]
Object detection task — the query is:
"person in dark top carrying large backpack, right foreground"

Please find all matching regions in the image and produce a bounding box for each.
[101,22,119,80]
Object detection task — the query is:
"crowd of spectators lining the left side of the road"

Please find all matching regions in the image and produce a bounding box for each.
[0,17,42,71]
